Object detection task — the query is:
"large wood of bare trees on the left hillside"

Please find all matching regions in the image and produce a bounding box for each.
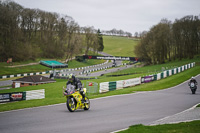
[0,0,104,61]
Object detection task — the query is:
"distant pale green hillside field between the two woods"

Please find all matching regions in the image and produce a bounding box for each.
[103,36,138,57]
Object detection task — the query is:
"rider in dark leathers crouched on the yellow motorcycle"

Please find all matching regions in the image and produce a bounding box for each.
[66,74,85,103]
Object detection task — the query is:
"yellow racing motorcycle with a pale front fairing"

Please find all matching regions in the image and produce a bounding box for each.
[63,84,90,112]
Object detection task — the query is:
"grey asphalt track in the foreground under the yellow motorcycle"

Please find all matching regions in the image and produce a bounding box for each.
[0,75,200,133]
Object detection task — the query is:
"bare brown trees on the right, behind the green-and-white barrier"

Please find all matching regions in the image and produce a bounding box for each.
[134,15,200,64]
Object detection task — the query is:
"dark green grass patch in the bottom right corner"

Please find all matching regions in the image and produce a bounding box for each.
[119,121,200,133]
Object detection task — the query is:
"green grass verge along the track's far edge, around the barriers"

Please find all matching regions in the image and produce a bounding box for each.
[0,57,200,111]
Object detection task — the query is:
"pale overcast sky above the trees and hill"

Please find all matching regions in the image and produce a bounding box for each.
[14,0,200,35]
